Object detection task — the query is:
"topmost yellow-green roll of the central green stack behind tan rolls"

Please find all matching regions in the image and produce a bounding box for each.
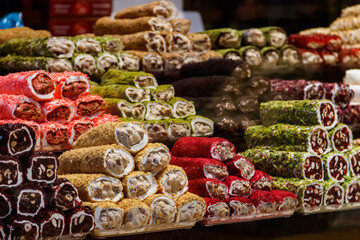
[101,69,158,89]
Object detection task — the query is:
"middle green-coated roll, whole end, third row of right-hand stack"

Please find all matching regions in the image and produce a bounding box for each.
[322,152,349,182]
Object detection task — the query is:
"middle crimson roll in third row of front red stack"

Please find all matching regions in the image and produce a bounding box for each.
[224,176,251,197]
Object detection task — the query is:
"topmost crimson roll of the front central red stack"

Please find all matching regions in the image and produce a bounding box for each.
[171,137,236,161]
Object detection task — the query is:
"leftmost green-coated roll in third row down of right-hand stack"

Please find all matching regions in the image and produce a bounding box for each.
[244,148,324,181]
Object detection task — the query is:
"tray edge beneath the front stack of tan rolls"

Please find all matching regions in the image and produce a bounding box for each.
[91,222,196,239]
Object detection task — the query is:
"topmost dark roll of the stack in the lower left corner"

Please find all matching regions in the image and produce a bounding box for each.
[0,123,36,158]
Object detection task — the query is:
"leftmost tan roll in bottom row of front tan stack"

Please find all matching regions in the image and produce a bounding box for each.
[83,202,124,232]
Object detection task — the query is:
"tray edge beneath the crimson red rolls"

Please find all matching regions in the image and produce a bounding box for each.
[199,209,295,227]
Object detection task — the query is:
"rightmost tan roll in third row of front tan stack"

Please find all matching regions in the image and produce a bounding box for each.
[156,165,188,198]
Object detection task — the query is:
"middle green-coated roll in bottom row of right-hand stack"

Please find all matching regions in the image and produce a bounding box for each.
[322,180,345,209]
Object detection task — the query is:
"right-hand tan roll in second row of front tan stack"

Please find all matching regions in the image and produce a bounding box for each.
[135,143,171,176]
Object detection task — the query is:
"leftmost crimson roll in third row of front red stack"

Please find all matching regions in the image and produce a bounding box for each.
[189,178,229,200]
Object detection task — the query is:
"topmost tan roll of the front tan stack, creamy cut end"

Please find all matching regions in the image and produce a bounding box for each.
[74,122,148,153]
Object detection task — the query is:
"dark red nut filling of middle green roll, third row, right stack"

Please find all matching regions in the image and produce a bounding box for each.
[327,154,349,181]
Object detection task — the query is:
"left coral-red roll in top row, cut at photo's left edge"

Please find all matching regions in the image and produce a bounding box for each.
[0,70,55,101]
